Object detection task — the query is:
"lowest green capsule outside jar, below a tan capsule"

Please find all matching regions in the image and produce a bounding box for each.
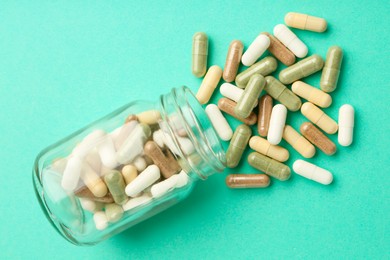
[248,152,291,181]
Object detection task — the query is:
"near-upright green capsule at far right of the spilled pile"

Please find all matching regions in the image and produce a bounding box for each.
[320,46,343,92]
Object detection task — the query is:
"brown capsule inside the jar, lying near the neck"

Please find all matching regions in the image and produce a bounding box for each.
[144,141,181,178]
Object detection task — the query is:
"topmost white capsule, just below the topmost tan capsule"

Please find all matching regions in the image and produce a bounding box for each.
[274,24,308,58]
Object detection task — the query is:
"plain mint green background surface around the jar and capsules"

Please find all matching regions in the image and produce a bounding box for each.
[0,0,390,259]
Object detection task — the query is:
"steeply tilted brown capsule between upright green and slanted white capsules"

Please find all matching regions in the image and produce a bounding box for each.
[222,40,244,82]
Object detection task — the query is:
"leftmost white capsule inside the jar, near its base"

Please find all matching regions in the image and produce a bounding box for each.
[61,156,83,191]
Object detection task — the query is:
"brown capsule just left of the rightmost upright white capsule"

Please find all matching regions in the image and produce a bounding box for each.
[300,122,337,155]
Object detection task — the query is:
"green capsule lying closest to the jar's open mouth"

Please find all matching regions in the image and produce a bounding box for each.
[226,125,252,168]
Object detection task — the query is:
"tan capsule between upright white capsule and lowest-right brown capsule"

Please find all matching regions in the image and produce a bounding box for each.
[283,125,316,158]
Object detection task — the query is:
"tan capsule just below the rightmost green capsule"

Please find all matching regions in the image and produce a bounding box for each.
[291,81,332,108]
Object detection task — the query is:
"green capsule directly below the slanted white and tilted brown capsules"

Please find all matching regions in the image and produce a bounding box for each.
[236,56,278,88]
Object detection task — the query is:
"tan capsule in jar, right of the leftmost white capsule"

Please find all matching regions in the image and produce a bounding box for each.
[80,163,108,198]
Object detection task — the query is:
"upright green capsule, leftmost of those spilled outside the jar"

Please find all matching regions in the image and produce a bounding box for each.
[192,32,209,78]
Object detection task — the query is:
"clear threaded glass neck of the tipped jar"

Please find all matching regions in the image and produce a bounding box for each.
[159,86,226,179]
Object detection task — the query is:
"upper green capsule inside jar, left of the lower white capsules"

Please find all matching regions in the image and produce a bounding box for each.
[104,170,127,205]
